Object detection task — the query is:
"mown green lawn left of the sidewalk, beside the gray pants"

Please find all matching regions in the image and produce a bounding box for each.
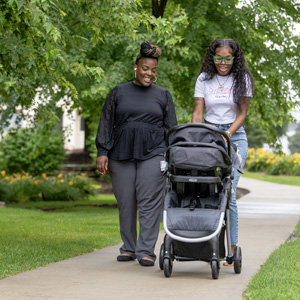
[0,195,121,279]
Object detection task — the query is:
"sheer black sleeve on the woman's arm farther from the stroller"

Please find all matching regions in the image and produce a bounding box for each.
[96,87,117,156]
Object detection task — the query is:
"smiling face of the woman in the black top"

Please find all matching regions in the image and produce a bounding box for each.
[134,57,158,87]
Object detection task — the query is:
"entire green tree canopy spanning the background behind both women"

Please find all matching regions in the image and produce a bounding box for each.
[0,0,300,150]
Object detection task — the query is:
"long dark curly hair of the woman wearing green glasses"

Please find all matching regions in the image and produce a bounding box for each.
[200,39,254,107]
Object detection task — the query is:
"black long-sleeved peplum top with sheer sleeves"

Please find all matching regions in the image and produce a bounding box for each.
[96,82,177,160]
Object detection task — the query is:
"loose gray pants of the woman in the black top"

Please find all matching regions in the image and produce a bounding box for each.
[108,155,165,260]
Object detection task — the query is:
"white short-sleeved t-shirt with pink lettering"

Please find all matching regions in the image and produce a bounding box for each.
[194,73,252,124]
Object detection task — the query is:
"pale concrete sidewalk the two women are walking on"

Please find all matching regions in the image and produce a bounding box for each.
[0,177,300,300]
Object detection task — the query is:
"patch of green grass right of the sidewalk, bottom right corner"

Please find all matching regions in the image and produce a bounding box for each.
[243,222,300,300]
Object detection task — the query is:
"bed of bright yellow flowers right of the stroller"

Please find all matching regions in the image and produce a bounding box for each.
[245,148,300,176]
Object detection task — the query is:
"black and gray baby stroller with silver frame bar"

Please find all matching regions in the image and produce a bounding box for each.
[159,123,242,279]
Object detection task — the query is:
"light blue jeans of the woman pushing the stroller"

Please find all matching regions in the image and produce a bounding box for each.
[210,125,248,245]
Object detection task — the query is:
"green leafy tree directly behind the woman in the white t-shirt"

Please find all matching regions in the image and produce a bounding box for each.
[165,0,300,148]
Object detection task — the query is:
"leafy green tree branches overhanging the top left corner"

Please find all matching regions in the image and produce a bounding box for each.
[0,0,157,129]
